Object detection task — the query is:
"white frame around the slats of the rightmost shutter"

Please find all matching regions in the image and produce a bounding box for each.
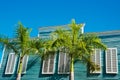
[106,48,118,74]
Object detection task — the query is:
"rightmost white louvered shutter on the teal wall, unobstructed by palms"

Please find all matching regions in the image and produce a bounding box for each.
[106,48,118,73]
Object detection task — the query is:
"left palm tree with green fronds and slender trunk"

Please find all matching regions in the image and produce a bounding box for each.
[0,22,43,80]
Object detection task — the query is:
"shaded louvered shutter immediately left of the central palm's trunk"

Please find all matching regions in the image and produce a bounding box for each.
[58,51,70,74]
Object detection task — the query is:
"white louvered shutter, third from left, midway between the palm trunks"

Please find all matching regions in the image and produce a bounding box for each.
[42,55,55,74]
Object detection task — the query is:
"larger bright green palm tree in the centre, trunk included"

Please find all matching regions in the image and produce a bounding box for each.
[51,19,106,80]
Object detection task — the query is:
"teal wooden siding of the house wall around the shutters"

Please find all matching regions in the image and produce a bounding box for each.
[0,32,120,80]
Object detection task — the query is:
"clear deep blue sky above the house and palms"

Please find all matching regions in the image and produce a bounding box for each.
[0,0,120,60]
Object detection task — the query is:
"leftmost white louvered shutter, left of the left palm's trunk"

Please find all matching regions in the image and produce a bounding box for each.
[5,53,17,74]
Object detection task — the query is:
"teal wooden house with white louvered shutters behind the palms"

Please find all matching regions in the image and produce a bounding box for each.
[0,25,120,80]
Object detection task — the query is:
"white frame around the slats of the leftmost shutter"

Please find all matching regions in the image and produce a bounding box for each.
[5,53,17,74]
